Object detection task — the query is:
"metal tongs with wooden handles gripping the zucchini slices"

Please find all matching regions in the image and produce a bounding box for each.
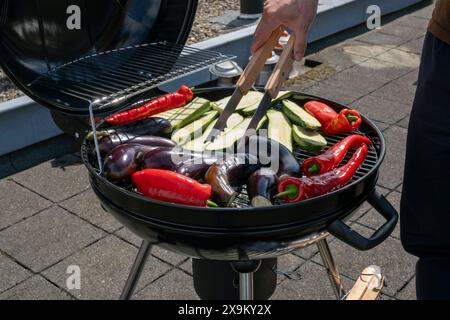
[205,27,295,143]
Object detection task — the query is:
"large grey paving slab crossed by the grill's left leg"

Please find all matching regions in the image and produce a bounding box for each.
[43,235,171,299]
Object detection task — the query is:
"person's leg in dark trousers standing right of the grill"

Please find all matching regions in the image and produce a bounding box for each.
[400,34,450,299]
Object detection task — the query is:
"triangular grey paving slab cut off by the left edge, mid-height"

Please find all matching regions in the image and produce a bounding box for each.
[0,179,51,230]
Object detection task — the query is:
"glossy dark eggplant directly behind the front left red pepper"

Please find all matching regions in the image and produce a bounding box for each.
[142,147,219,180]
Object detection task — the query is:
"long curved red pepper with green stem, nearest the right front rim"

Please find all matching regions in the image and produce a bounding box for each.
[275,144,369,203]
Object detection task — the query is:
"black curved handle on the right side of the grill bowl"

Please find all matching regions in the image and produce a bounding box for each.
[328,190,398,251]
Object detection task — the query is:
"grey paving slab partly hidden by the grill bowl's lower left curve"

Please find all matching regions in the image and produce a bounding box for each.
[61,189,122,232]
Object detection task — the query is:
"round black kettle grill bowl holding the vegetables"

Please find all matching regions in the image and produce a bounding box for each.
[82,88,385,260]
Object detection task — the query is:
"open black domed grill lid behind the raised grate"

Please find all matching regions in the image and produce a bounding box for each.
[0,0,207,114]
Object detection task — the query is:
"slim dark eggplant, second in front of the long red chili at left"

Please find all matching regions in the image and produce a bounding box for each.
[87,130,176,157]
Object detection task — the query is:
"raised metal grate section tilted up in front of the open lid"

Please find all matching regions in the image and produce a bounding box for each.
[28,42,235,109]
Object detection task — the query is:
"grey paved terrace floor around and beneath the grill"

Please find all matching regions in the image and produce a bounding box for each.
[0,1,432,299]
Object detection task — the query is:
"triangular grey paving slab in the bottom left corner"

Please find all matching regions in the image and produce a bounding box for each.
[0,275,72,300]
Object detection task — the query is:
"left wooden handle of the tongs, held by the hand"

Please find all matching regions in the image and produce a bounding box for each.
[236,27,283,95]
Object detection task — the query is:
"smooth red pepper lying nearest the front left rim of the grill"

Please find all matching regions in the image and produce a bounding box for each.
[132,169,212,207]
